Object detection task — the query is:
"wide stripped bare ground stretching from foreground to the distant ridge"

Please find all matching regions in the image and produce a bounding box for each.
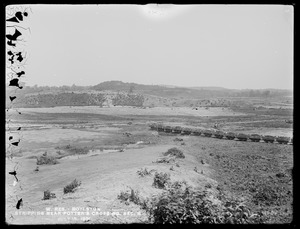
[6,107,293,224]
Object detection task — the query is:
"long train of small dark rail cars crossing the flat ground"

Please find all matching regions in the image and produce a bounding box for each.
[149,123,293,145]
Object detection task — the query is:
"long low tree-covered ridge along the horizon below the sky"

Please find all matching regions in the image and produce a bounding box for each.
[6,81,293,107]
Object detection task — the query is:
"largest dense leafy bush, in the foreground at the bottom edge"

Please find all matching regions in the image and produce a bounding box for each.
[142,182,263,224]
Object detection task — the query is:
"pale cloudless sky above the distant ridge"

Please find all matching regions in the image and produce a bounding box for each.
[6,4,294,89]
